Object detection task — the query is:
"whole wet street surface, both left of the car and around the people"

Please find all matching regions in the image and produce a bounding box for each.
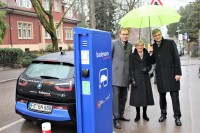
[0,55,200,133]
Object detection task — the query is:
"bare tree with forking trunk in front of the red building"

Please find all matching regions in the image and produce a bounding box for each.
[31,0,76,51]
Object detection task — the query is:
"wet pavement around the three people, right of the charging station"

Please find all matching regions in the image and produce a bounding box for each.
[114,55,200,133]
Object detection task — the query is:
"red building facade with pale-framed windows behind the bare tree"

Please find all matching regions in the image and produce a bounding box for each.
[0,0,79,51]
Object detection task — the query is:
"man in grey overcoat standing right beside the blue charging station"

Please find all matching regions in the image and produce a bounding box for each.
[112,28,132,129]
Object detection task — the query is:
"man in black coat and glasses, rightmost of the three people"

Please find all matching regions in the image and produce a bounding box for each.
[151,29,182,126]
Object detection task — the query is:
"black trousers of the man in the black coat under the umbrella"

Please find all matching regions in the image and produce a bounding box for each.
[159,91,181,119]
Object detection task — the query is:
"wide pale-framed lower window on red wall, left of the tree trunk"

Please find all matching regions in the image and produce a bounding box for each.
[17,22,33,39]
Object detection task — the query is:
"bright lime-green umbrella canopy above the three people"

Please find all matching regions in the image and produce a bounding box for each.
[119,5,181,28]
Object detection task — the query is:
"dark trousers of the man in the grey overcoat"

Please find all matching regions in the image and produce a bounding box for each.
[112,85,128,119]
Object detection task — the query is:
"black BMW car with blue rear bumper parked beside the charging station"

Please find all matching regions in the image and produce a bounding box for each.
[15,52,76,122]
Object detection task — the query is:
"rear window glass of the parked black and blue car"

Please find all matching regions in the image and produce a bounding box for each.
[25,63,73,79]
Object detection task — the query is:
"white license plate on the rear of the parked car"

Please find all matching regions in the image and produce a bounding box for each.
[28,102,52,113]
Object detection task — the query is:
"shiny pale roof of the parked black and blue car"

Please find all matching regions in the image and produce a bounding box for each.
[33,51,74,65]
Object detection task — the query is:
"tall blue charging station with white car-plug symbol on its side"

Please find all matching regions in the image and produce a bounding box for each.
[74,27,113,133]
